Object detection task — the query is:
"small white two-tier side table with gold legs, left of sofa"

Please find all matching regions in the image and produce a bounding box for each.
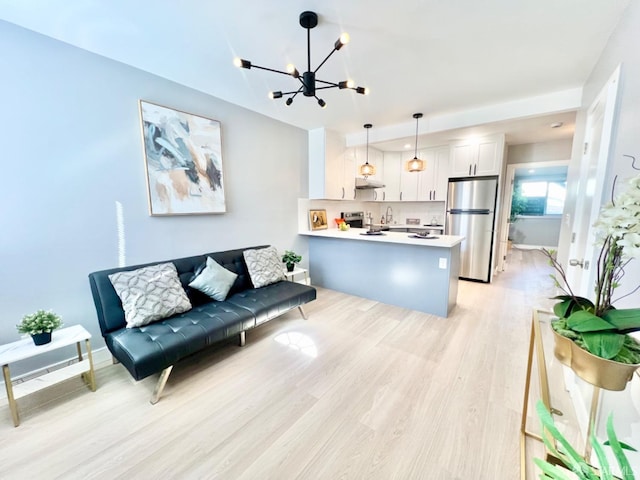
[0,325,96,427]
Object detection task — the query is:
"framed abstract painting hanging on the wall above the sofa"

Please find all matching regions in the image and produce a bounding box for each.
[139,100,226,216]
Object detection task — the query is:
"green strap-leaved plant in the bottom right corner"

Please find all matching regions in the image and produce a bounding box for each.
[533,400,637,480]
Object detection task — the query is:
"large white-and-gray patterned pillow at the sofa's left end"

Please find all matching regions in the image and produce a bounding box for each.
[109,263,191,328]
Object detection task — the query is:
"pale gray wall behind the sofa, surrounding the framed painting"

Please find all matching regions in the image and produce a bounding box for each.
[0,22,308,373]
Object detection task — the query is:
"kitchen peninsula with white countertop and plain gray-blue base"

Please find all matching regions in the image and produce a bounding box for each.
[300,228,464,317]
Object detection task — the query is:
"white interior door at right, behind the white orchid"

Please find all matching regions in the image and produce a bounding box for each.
[565,67,620,298]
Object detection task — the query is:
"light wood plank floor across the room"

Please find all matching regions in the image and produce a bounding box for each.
[0,250,553,480]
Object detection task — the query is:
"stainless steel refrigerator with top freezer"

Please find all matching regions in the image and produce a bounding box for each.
[446,177,498,282]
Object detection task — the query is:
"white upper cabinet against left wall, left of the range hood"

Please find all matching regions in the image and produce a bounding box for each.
[309,128,356,200]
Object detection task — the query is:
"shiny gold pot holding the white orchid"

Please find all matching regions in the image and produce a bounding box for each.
[550,327,640,391]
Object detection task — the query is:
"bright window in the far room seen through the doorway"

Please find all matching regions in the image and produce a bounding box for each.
[512,178,567,216]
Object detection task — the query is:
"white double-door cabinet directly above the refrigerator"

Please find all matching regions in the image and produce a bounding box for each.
[449,135,504,177]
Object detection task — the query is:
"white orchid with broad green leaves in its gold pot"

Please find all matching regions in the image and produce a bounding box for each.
[542,175,640,390]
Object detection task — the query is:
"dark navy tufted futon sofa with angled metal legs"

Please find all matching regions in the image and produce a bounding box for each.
[89,246,316,404]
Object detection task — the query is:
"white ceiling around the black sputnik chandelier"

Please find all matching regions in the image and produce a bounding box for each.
[0,0,631,148]
